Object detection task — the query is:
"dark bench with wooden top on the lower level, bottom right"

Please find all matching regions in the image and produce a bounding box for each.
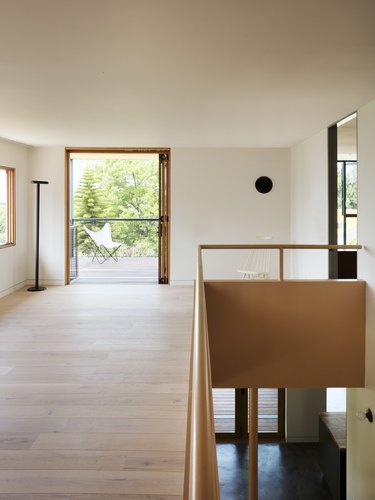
[319,412,346,500]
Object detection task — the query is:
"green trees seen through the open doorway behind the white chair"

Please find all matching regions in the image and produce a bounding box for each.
[73,157,159,257]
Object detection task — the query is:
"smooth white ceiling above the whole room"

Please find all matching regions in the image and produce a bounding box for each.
[0,0,375,147]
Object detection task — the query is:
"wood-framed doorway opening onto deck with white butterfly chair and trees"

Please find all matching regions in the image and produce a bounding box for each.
[66,148,170,284]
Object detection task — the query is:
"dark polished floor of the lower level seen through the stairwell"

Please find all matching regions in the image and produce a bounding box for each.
[217,443,332,500]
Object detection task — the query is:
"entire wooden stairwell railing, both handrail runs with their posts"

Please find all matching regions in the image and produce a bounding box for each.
[184,244,362,500]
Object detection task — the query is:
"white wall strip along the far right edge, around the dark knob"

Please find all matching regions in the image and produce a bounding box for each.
[347,97,375,500]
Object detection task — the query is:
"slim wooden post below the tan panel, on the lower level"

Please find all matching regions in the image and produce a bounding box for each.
[249,389,258,500]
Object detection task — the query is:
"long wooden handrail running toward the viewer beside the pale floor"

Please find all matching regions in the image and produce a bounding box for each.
[184,248,220,500]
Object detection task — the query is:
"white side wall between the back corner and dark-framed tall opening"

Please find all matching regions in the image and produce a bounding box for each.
[291,130,328,278]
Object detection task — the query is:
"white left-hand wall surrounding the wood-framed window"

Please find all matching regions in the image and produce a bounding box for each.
[0,139,31,296]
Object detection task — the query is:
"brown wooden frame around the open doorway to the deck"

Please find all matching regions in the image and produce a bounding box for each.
[65,147,171,285]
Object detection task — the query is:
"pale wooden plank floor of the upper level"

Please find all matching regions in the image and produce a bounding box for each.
[0,284,192,500]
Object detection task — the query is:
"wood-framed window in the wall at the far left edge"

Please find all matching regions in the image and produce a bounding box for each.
[0,166,15,248]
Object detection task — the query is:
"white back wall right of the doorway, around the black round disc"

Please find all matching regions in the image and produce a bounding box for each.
[171,148,290,284]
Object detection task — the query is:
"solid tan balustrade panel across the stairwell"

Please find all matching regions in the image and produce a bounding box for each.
[205,280,366,387]
